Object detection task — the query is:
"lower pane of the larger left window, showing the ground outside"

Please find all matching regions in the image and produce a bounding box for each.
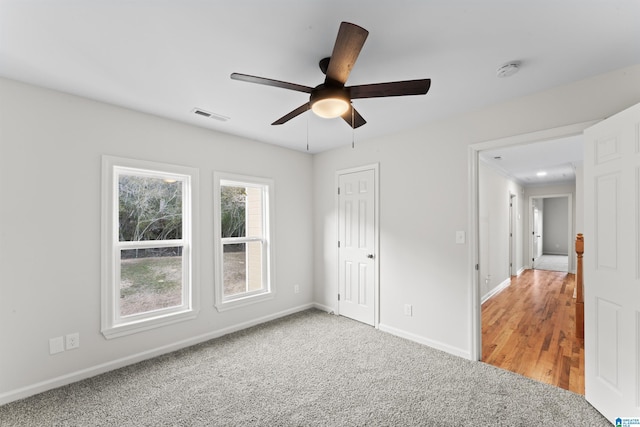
[120,247,182,316]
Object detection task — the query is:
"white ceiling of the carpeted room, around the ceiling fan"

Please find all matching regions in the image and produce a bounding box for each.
[0,0,640,152]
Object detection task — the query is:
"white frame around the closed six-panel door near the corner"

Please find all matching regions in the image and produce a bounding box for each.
[333,163,380,329]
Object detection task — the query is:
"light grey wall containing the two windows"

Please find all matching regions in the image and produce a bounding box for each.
[0,79,313,403]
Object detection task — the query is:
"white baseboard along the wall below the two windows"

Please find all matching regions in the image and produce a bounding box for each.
[0,303,322,405]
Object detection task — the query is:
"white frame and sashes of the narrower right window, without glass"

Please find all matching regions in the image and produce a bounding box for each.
[213,171,275,311]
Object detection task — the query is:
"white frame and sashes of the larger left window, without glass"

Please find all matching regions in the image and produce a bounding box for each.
[101,155,199,339]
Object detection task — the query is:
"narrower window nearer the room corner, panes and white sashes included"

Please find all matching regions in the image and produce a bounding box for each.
[214,173,274,310]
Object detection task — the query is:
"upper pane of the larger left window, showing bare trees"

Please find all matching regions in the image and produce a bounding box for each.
[118,174,182,242]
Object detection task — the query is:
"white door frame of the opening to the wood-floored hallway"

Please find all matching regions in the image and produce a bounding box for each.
[468,120,600,360]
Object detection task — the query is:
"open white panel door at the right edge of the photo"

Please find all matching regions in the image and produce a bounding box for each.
[584,104,640,423]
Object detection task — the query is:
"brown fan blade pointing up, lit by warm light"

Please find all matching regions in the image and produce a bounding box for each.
[325,22,369,86]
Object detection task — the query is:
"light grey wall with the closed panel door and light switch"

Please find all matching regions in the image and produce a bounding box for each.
[314,62,640,358]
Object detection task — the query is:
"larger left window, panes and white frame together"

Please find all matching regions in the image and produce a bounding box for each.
[102,156,198,338]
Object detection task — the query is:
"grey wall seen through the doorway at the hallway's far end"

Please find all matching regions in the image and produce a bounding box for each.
[542,197,575,255]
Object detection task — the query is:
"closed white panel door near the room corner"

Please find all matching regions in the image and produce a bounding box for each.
[338,169,376,326]
